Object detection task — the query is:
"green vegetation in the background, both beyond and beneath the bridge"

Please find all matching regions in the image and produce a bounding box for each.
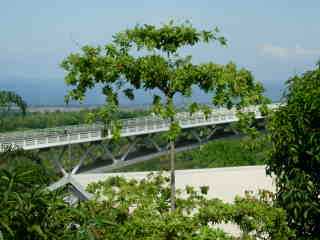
[0,103,263,174]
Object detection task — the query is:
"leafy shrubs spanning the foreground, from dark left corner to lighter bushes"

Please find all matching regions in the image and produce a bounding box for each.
[0,164,292,240]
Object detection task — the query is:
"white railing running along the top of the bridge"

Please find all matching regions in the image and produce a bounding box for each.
[0,104,279,152]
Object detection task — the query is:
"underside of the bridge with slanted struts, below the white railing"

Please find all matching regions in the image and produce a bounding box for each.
[40,125,242,200]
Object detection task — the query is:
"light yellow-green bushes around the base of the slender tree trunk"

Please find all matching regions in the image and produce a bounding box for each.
[83,175,292,240]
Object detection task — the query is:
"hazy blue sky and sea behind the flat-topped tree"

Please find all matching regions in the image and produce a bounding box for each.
[0,0,320,105]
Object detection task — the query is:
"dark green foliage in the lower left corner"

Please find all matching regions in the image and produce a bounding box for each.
[0,162,65,240]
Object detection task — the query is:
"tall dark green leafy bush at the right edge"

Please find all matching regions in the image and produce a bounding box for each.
[268,61,320,239]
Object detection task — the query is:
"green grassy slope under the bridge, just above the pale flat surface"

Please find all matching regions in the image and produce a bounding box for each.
[114,139,267,172]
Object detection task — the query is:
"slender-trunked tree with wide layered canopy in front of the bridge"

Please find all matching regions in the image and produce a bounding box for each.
[62,21,265,210]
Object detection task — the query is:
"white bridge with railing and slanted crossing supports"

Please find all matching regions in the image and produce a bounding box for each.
[0,103,279,199]
